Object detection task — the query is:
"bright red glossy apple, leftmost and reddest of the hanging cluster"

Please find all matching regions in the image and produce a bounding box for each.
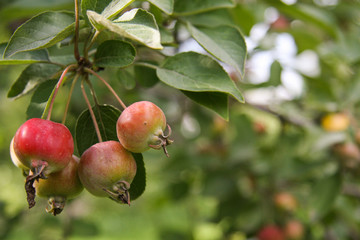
[13,118,74,175]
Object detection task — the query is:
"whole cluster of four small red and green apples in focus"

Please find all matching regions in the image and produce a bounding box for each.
[10,101,172,216]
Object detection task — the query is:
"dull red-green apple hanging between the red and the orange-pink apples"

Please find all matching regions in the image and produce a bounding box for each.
[78,141,136,204]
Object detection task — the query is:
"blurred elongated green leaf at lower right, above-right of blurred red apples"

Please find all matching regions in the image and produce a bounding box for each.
[310,172,342,221]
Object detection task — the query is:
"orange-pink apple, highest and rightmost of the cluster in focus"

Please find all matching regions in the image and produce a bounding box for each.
[116,101,172,155]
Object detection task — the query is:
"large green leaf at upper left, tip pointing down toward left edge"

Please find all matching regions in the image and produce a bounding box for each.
[4,12,74,58]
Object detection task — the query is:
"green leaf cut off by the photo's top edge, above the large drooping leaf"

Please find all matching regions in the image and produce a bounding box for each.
[174,0,235,15]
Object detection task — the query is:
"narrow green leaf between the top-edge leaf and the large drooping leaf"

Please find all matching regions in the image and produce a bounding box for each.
[184,9,234,27]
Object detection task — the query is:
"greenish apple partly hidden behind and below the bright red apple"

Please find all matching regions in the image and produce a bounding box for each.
[34,156,84,216]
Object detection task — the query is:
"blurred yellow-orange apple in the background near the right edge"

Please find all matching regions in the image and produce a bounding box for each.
[321,113,350,132]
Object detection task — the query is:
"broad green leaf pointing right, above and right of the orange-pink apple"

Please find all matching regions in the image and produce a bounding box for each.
[157,52,244,102]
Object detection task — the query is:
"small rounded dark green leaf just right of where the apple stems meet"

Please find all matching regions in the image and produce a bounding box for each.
[94,40,136,67]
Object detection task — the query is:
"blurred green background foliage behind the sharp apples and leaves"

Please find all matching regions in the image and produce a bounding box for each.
[0,0,360,240]
